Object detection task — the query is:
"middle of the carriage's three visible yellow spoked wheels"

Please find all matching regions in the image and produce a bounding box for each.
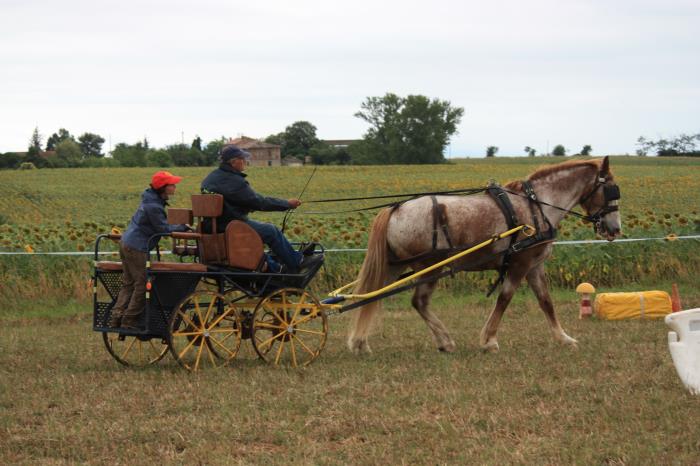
[169,291,241,371]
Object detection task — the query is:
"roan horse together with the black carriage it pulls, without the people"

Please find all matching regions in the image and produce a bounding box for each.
[93,157,620,370]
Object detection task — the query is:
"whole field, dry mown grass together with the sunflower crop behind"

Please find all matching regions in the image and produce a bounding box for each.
[0,157,700,465]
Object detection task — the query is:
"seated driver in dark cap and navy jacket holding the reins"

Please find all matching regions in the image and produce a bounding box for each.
[201,145,321,273]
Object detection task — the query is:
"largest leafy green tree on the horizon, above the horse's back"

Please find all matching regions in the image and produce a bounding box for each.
[351,93,464,164]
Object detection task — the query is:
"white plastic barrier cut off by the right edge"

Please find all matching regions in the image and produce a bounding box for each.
[664,308,700,395]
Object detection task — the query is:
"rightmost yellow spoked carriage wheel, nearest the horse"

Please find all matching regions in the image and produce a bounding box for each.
[251,288,328,367]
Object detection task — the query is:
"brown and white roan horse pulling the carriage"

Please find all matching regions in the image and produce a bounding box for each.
[348,157,621,353]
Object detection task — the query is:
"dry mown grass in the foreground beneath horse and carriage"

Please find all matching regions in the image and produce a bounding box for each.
[0,293,700,464]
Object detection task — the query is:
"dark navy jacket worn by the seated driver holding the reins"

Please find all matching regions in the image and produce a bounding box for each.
[201,163,291,231]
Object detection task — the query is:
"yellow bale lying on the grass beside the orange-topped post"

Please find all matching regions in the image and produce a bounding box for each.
[595,290,671,320]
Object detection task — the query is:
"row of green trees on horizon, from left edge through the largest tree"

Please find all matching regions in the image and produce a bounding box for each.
[0,93,464,168]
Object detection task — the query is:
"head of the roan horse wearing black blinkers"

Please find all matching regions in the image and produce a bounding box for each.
[579,157,622,241]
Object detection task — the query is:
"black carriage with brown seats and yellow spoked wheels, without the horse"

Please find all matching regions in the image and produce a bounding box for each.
[93,194,328,370]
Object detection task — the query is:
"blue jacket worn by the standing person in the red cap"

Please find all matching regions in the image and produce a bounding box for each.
[122,188,187,252]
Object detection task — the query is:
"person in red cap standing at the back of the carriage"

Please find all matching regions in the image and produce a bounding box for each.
[108,171,190,328]
